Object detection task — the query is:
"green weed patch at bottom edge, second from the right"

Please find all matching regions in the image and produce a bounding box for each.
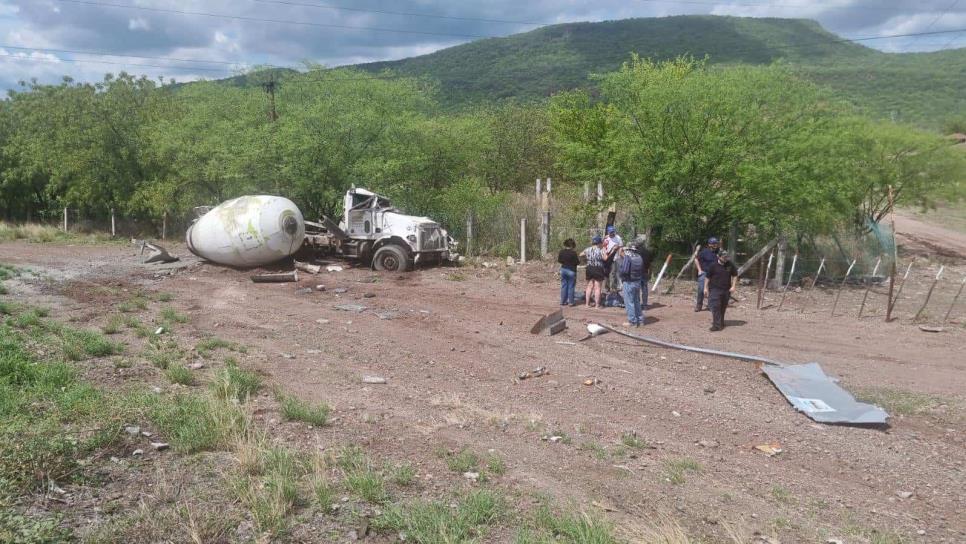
[372,489,506,544]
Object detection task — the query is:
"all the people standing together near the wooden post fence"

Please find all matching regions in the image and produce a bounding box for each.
[557,231,738,331]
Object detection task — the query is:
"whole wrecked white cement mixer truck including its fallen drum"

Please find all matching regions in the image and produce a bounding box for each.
[186,188,459,272]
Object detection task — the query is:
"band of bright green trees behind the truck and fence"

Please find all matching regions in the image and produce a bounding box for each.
[0,57,966,245]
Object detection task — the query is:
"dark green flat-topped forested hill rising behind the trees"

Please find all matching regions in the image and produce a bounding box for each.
[358,16,966,127]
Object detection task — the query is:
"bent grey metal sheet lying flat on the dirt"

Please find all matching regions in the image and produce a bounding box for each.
[761,363,889,425]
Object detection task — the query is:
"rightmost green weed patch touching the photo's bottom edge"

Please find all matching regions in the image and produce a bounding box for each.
[516,504,619,544]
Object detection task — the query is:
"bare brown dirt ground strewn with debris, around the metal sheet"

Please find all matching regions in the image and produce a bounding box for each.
[0,243,966,542]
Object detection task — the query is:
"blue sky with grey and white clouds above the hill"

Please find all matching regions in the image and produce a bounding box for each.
[0,0,966,89]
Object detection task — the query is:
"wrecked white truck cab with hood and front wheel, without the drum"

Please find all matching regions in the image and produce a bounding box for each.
[339,187,458,271]
